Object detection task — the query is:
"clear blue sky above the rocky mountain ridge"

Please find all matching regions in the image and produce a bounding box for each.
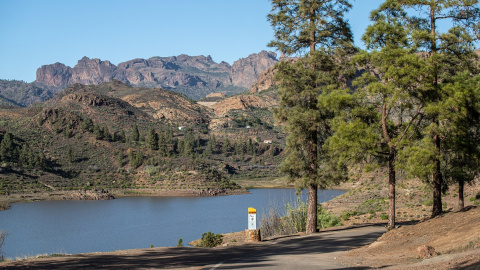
[0,0,382,82]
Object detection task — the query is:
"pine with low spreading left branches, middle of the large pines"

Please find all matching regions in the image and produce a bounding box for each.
[328,2,425,229]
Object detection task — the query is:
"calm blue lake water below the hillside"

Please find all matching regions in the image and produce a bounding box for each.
[0,189,344,258]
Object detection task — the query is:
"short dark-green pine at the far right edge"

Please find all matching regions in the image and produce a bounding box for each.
[442,72,480,210]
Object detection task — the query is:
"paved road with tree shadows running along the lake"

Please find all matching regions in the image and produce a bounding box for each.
[0,225,385,270]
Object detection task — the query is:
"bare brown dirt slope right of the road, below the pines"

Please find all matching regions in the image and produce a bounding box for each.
[342,206,480,270]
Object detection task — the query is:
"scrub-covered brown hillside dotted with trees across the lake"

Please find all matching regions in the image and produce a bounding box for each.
[0,80,285,207]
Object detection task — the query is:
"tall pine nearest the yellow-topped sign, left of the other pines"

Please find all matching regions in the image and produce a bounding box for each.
[268,0,352,233]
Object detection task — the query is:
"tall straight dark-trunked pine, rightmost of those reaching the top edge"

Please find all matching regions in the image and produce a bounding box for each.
[383,0,480,217]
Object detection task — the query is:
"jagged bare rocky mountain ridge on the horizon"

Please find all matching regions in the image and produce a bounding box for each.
[36,51,278,99]
